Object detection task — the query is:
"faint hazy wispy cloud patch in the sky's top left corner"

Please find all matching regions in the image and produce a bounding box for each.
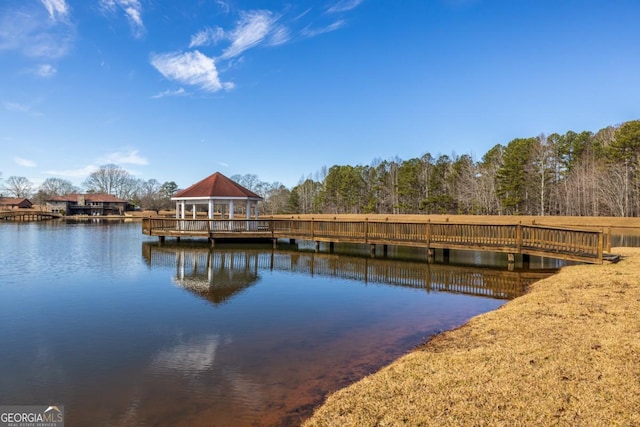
[0,1,75,58]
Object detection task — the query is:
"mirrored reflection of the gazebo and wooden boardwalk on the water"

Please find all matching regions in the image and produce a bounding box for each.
[142,242,557,305]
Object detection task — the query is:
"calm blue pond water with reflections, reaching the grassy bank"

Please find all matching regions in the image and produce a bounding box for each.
[0,222,556,426]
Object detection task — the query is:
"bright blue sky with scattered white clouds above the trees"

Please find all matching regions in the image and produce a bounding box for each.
[0,0,640,188]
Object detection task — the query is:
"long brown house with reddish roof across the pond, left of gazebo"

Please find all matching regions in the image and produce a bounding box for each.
[46,194,128,216]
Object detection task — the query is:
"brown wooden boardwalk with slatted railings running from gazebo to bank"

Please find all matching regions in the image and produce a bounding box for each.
[142,218,612,264]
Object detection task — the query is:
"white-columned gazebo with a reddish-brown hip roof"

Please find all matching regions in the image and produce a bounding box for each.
[171,172,262,219]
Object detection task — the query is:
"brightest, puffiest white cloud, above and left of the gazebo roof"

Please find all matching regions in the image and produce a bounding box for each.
[151,50,233,92]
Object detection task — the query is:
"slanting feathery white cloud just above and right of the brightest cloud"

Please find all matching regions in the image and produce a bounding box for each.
[221,10,277,59]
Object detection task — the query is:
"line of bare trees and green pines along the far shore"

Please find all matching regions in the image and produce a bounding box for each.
[0,120,640,216]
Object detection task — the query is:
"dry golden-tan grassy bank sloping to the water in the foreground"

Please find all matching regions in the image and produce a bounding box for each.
[305,248,640,426]
